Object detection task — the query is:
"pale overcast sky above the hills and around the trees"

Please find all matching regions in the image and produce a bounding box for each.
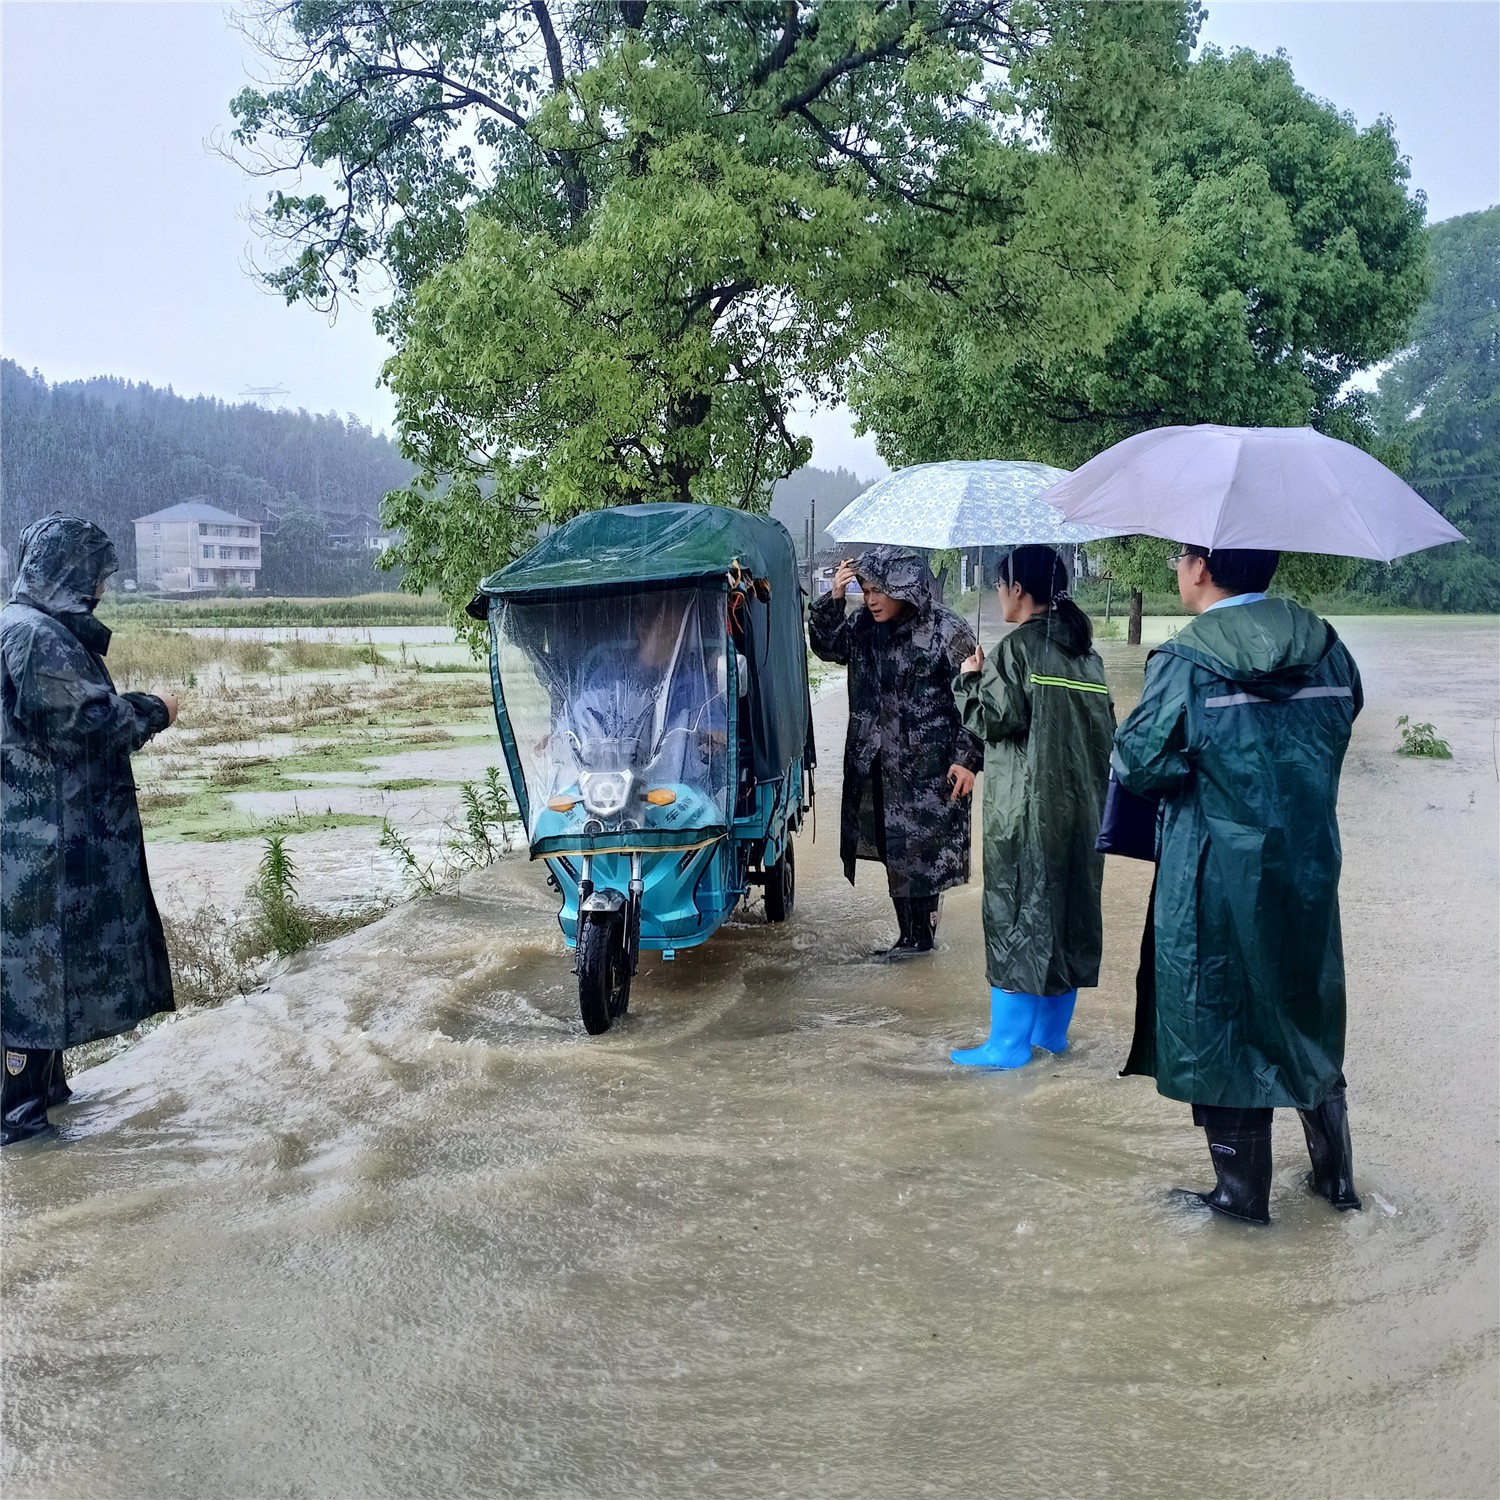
[0,0,1500,477]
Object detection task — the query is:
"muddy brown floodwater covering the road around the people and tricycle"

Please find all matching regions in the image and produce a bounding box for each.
[0,621,1500,1500]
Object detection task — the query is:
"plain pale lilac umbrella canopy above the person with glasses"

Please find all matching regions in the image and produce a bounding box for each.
[1047,426,1464,563]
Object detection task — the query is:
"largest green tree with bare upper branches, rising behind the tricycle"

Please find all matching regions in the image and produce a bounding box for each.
[234,0,1194,621]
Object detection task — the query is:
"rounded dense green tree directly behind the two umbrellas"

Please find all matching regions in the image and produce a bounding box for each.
[855,50,1425,639]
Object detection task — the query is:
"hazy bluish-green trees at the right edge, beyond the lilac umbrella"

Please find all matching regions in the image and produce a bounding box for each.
[1368,207,1500,611]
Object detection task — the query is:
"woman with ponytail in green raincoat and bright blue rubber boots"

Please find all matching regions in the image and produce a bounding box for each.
[951,546,1115,1068]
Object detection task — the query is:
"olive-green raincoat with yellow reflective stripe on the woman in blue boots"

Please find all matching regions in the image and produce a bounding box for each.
[954,612,1115,995]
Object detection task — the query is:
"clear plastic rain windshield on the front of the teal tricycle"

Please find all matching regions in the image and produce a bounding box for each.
[491,587,729,852]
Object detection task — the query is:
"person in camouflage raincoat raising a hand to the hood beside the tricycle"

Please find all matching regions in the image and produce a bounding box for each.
[809,546,984,957]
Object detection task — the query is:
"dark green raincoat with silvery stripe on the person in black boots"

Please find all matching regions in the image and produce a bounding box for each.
[1113,599,1364,1109]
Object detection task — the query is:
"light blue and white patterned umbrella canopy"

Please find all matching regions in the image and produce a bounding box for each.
[828,459,1119,548]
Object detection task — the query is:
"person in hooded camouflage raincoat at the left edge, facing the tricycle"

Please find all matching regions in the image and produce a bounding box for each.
[0,515,176,1145]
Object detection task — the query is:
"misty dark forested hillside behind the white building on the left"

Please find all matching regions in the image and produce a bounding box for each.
[0,360,413,593]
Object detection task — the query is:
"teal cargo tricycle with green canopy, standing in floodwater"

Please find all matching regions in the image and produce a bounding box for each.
[476,506,813,1034]
